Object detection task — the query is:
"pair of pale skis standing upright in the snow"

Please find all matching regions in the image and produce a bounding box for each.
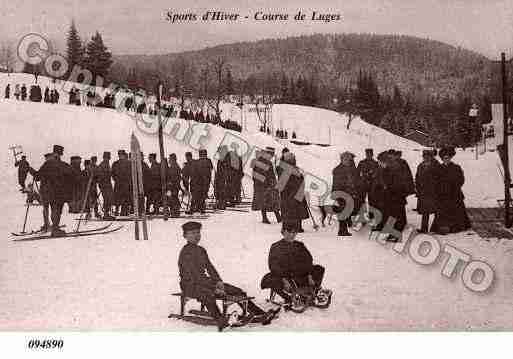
[130,133,148,241]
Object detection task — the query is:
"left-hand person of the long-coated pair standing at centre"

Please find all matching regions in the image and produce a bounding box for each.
[251,151,282,223]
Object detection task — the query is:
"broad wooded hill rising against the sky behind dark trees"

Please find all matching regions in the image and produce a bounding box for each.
[114,34,491,99]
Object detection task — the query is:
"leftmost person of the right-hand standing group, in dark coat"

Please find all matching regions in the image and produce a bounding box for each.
[332,151,361,237]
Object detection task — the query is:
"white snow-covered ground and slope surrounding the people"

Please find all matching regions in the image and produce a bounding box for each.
[0,74,513,331]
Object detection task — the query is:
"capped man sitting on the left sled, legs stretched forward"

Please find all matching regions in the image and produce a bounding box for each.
[178,222,279,330]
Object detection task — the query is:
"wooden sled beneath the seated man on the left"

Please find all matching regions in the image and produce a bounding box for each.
[168,293,261,328]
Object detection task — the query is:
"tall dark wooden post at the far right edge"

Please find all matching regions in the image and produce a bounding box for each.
[501,52,511,228]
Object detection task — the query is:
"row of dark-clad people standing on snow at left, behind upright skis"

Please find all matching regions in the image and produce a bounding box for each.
[15,145,243,235]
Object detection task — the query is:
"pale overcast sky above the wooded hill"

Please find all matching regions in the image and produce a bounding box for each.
[0,0,513,59]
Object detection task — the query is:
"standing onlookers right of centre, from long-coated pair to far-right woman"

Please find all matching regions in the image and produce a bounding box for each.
[251,147,471,242]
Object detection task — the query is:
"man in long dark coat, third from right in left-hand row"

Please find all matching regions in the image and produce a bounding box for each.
[189,149,213,213]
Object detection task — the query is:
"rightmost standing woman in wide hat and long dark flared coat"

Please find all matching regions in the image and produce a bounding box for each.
[431,148,472,234]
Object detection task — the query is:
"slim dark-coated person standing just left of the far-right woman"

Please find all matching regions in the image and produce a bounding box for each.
[415,150,440,233]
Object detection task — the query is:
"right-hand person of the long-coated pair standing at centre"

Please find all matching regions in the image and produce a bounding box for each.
[278,152,309,233]
